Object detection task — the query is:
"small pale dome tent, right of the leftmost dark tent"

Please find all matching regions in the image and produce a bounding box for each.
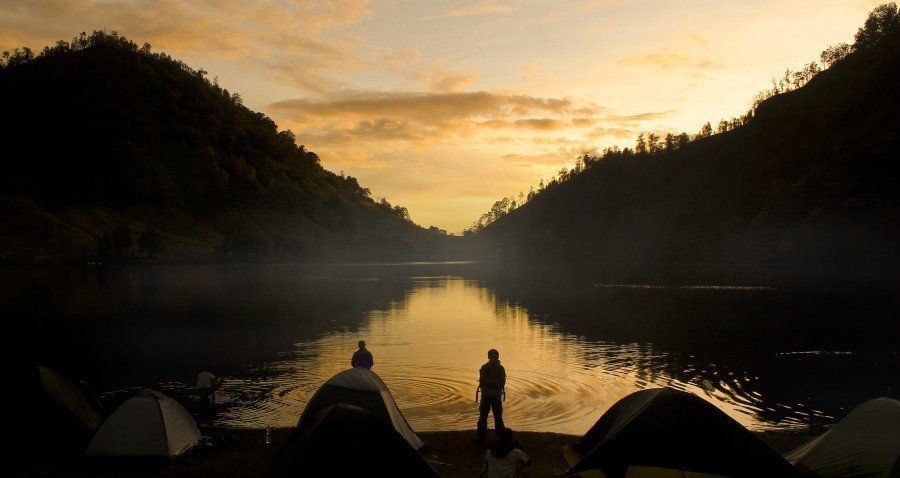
[85,392,200,457]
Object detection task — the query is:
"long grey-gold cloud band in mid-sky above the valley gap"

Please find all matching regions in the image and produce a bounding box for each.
[268,91,600,148]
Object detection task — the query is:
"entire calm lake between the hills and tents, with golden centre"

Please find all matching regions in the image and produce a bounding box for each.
[0,263,900,434]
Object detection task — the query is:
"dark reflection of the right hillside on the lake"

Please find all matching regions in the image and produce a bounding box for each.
[472,268,900,427]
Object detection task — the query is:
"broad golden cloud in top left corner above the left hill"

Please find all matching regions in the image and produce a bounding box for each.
[0,0,371,92]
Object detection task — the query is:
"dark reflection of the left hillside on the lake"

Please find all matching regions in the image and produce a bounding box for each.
[6,266,410,389]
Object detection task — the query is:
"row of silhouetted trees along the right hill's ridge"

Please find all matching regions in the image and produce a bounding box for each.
[464,2,898,235]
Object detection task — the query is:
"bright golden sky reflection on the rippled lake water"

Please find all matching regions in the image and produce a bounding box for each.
[214,278,832,434]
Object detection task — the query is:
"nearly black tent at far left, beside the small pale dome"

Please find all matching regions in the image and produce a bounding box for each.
[13,367,103,459]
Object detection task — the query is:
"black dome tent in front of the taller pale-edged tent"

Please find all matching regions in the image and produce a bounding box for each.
[272,404,439,477]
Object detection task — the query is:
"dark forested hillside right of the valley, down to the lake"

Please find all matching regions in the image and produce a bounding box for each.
[474,4,900,274]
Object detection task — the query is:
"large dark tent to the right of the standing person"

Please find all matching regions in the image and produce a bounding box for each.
[564,388,796,478]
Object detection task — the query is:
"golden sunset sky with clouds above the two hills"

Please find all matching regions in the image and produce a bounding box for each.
[0,0,881,232]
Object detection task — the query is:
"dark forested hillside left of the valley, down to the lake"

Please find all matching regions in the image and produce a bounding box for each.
[0,32,444,262]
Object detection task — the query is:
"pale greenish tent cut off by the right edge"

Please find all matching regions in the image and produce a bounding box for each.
[785,397,900,477]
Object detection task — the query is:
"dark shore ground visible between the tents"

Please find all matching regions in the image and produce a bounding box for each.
[14,428,813,478]
